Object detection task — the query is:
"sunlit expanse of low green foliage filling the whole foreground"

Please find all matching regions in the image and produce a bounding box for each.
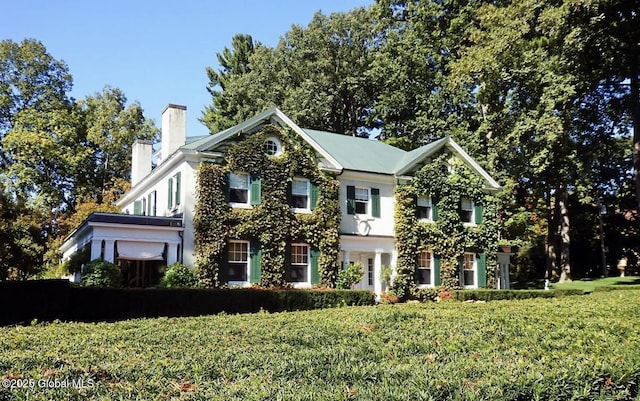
[0,290,640,400]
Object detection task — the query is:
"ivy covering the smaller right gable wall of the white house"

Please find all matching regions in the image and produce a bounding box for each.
[393,152,498,299]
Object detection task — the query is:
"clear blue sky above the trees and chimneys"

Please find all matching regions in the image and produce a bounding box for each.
[0,0,374,136]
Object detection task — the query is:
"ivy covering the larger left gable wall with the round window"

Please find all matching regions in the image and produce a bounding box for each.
[194,125,340,287]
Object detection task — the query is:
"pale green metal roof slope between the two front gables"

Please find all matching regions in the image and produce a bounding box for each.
[303,129,407,174]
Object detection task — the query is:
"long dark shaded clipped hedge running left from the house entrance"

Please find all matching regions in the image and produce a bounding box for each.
[0,280,375,325]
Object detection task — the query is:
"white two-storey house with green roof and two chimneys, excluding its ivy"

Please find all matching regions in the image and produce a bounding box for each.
[61,104,500,294]
